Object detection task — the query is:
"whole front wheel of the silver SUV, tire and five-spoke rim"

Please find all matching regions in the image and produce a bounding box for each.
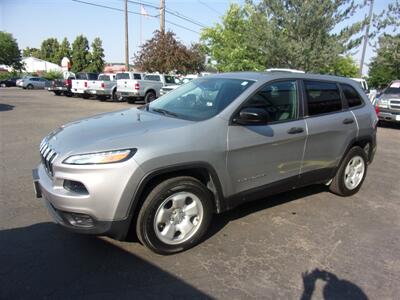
[136,176,212,254]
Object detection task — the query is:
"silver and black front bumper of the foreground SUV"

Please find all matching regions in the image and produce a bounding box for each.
[32,159,143,239]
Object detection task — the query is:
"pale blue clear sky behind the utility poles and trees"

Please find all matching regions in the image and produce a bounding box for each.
[0,0,391,74]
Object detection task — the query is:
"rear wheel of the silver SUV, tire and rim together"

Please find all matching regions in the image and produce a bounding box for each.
[329,146,368,197]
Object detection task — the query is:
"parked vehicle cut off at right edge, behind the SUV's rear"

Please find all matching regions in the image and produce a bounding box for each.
[376,80,400,122]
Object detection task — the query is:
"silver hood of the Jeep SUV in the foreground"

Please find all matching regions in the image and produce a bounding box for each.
[45,108,192,156]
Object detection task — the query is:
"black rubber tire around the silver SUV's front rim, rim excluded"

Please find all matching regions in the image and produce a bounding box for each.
[138,180,212,254]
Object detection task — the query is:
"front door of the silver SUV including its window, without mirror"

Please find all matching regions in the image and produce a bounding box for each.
[227,80,307,194]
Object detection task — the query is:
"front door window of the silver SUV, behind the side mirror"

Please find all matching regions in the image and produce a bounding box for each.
[245,80,297,122]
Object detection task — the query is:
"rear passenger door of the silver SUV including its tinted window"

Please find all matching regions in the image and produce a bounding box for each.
[301,80,358,184]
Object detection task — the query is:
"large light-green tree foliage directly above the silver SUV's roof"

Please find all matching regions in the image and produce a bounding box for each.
[201,0,364,72]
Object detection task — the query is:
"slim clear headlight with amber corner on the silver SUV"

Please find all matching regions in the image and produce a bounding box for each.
[63,149,136,165]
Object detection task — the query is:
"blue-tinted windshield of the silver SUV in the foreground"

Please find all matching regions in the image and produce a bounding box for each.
[146,78,254,121]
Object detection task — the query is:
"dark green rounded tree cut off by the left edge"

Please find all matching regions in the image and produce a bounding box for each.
[0,31,23,70]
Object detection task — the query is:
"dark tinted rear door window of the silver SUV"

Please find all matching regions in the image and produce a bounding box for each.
[304,81,342,116]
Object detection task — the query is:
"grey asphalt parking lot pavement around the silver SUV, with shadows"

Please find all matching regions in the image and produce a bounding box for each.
[0,88,400,300]
